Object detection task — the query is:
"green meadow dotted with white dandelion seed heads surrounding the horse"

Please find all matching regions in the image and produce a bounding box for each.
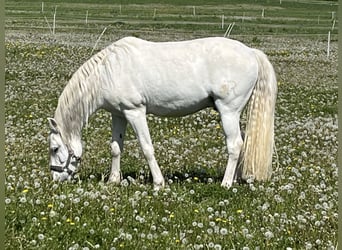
[5,0,338,250]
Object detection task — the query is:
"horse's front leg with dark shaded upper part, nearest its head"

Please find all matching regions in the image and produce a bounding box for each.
[108,114,127,184]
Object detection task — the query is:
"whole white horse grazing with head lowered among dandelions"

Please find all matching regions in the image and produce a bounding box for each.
[49,37,277,189]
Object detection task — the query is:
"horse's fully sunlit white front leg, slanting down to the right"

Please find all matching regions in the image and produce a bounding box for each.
[124,108,165,190]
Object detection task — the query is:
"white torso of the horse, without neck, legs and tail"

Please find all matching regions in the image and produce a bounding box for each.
[103,37,257,115]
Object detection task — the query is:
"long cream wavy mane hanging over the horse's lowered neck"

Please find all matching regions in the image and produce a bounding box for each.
[55,49,109,142]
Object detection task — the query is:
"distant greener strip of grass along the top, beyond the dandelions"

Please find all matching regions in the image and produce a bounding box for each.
[5,1,338,35]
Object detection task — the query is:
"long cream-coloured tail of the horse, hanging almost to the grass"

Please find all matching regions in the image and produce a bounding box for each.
[241,49,277,180]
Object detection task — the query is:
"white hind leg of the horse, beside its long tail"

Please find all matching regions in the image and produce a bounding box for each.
[217,101,243,188]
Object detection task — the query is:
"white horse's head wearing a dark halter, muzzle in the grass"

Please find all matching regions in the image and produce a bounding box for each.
[48,118,80,181]
